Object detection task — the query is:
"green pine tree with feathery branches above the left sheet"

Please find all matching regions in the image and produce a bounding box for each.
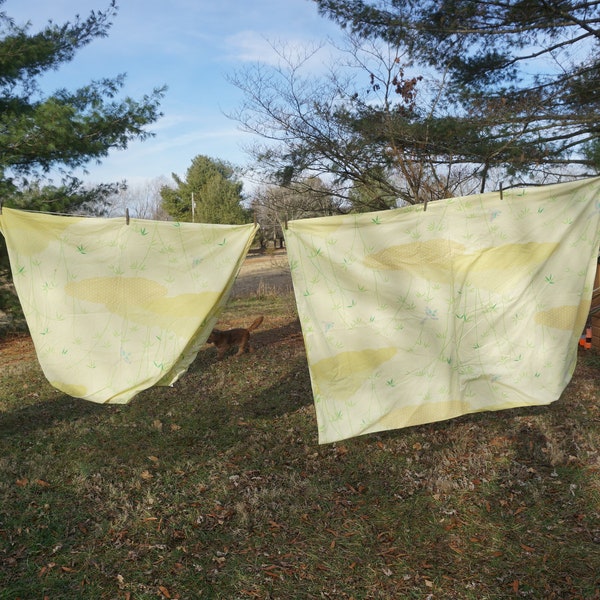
[0,0,165,210]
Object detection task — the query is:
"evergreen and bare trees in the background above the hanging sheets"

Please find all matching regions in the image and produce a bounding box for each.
[0,0,600,235]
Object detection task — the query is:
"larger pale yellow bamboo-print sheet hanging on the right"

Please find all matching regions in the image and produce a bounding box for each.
[285,178,600,443]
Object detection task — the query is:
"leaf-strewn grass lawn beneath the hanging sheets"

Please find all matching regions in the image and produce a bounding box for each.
[0,294,600,600]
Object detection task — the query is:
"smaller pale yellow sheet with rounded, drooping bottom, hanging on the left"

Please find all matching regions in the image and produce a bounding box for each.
[0,208,257,403]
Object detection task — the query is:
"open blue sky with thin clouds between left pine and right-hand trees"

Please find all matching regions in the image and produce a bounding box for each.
[7,0,340,185]
